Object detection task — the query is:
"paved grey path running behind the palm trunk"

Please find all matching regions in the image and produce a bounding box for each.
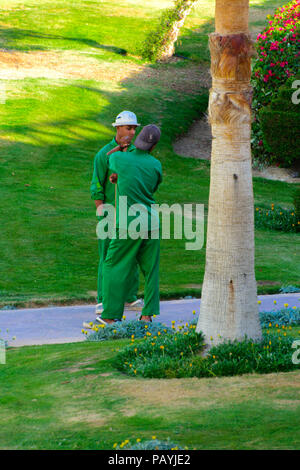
[0,293,300,346]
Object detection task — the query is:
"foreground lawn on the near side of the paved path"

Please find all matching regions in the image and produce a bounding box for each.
[0,326,300,450]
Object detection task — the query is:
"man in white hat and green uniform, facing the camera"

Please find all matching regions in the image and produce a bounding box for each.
[91,111,143,314]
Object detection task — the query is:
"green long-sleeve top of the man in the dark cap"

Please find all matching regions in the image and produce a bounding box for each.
[109,149,162,230]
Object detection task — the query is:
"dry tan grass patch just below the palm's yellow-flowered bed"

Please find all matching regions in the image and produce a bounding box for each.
[111,372,300,408]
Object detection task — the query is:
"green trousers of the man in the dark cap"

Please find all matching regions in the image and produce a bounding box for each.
[101,234,160,320]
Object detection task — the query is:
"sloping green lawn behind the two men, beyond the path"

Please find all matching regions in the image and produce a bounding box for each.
[0,0,300,306]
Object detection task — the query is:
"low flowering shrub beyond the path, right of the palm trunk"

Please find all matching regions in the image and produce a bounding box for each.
[254,204,300,232]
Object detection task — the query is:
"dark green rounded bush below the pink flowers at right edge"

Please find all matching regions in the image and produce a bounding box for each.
[259,77,300,167]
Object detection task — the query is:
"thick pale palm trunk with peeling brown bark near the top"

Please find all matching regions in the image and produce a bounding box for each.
[197,0,261,346]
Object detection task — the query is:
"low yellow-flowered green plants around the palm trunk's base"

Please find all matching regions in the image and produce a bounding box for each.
[113,325,300,378]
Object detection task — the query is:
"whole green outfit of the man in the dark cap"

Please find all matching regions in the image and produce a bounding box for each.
[101,149,162,320]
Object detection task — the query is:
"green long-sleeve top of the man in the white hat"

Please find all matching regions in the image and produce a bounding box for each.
[91,138,135,205]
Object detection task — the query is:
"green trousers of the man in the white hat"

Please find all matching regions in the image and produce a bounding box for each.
[97,238,139,303]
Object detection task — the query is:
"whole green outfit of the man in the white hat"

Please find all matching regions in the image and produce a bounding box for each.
[91,138,139,303]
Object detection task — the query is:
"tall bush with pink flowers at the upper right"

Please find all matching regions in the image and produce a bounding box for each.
[252,0,300,164]
